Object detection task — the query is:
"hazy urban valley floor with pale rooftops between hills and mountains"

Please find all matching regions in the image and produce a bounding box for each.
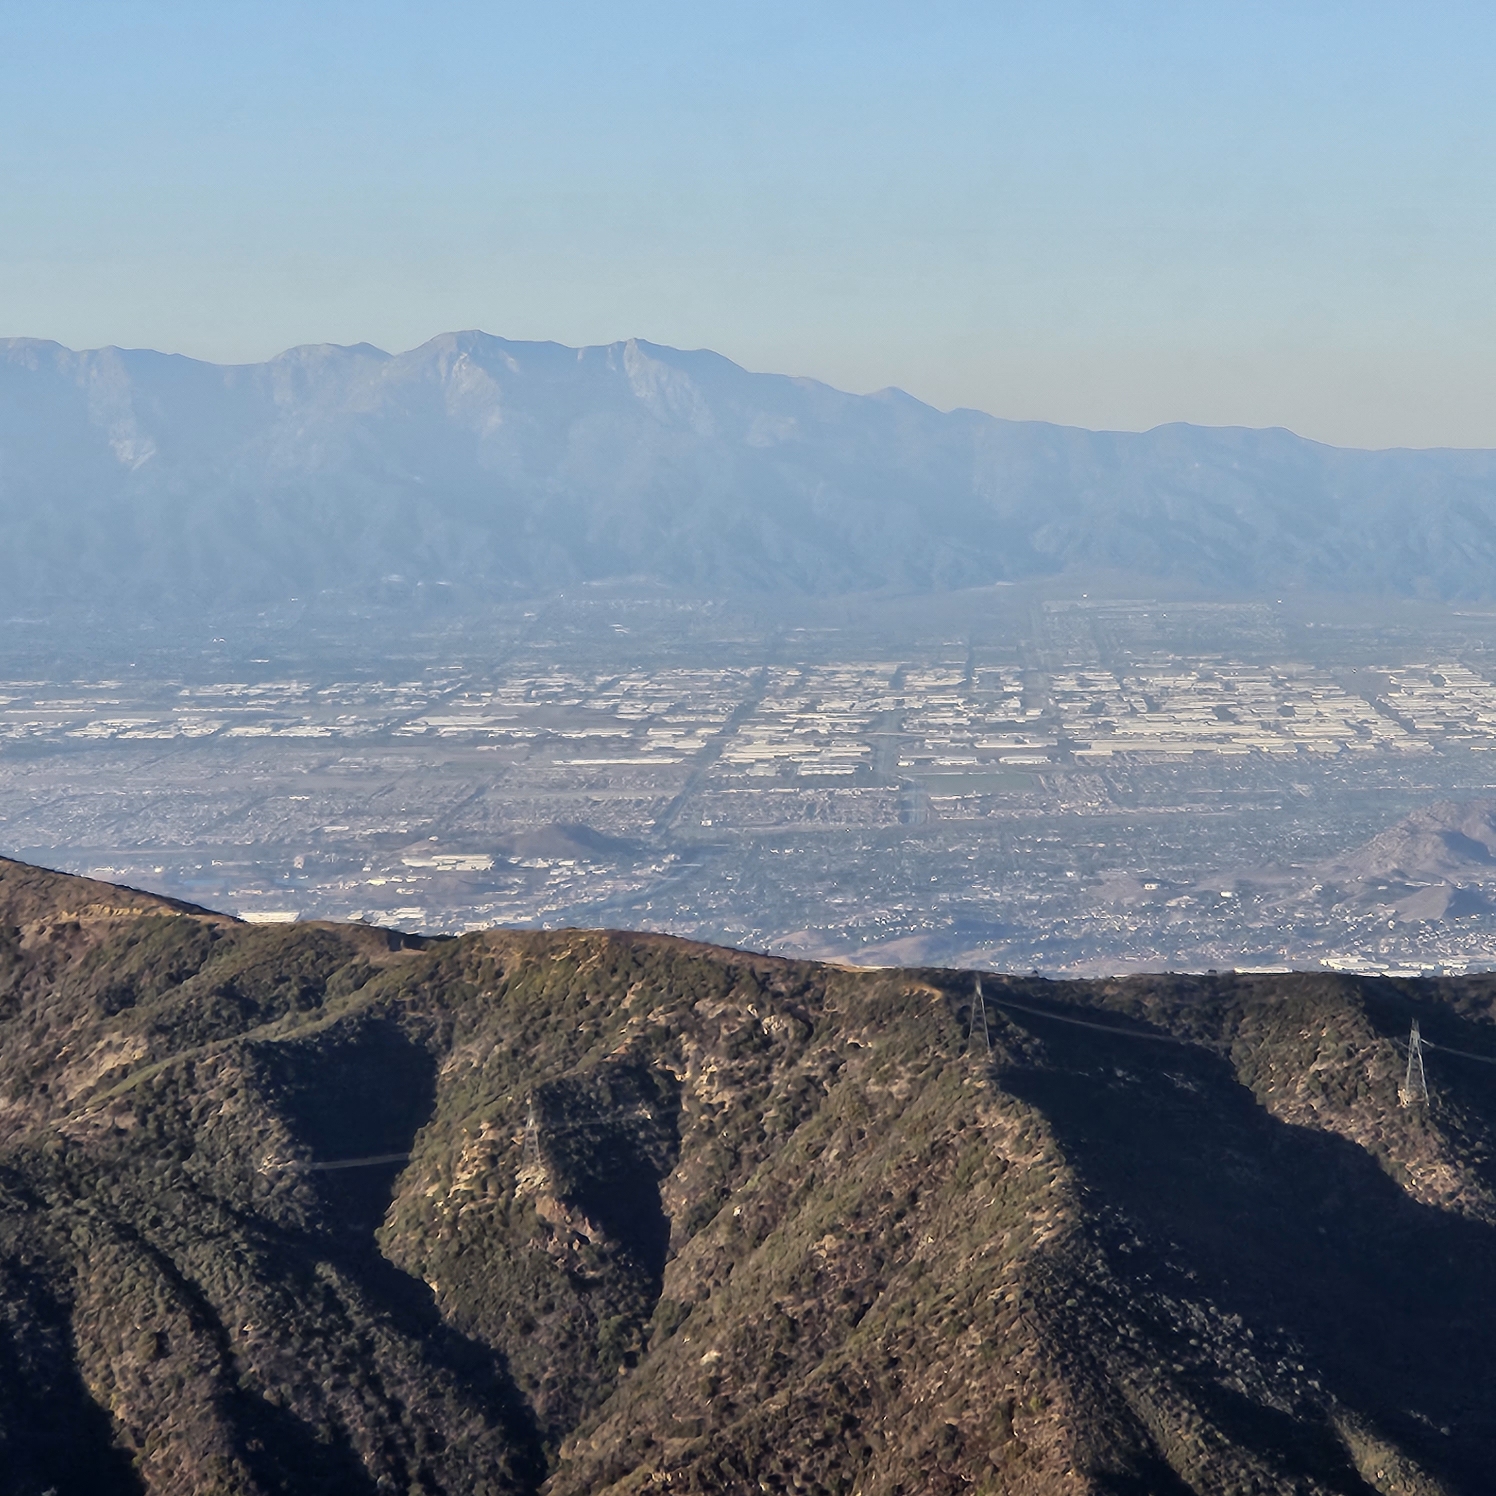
[14,588,1496,972]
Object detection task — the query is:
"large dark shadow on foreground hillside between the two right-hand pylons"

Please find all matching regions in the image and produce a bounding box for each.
[1001,1014,1496,1493]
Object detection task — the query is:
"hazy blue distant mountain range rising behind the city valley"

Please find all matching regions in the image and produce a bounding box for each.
[0,332,1496,609]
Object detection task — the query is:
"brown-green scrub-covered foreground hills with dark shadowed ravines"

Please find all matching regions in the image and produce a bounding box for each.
[0,863,1496,1496]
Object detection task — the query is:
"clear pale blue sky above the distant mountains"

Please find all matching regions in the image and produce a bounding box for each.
[0,0,1496,446]
